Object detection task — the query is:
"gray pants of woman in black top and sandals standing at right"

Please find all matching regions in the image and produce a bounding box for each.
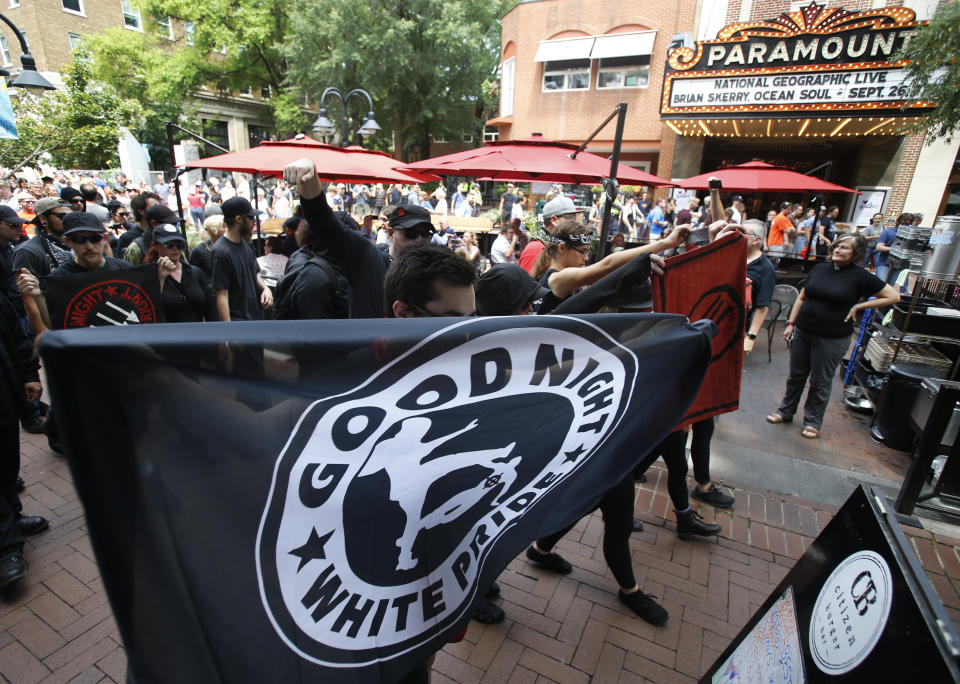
[777,328,850,430]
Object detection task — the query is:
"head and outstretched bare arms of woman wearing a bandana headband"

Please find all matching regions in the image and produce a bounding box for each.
[533,219,690,314]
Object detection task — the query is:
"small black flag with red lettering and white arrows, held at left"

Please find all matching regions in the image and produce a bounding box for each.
[41,265,163,330]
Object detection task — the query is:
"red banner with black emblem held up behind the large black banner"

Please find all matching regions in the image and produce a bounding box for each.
[652,235,747,426]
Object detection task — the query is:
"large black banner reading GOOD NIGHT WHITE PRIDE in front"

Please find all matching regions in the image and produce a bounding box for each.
[41,314,711,683]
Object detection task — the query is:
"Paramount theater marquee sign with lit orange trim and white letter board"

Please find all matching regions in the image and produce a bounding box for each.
[660,3,932,135]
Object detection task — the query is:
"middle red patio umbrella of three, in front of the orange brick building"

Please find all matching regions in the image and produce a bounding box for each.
[399,135,674,187]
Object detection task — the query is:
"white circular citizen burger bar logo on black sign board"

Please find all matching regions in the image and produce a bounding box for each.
[810,551,893,675]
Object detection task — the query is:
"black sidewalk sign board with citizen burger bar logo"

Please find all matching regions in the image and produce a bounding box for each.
[700,485,960,684]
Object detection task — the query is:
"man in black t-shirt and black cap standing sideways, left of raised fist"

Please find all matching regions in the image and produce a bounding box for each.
[210,197,273,321]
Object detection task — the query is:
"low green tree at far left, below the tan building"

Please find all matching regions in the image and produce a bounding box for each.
[0,52,140,169]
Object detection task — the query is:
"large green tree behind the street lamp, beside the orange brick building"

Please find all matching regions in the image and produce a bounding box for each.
[285,0,512,160]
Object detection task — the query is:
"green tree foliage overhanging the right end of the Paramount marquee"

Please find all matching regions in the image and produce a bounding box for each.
[896,2,960,138]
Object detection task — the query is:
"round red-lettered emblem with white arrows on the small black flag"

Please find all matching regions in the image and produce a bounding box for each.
[63,280,157,328]
